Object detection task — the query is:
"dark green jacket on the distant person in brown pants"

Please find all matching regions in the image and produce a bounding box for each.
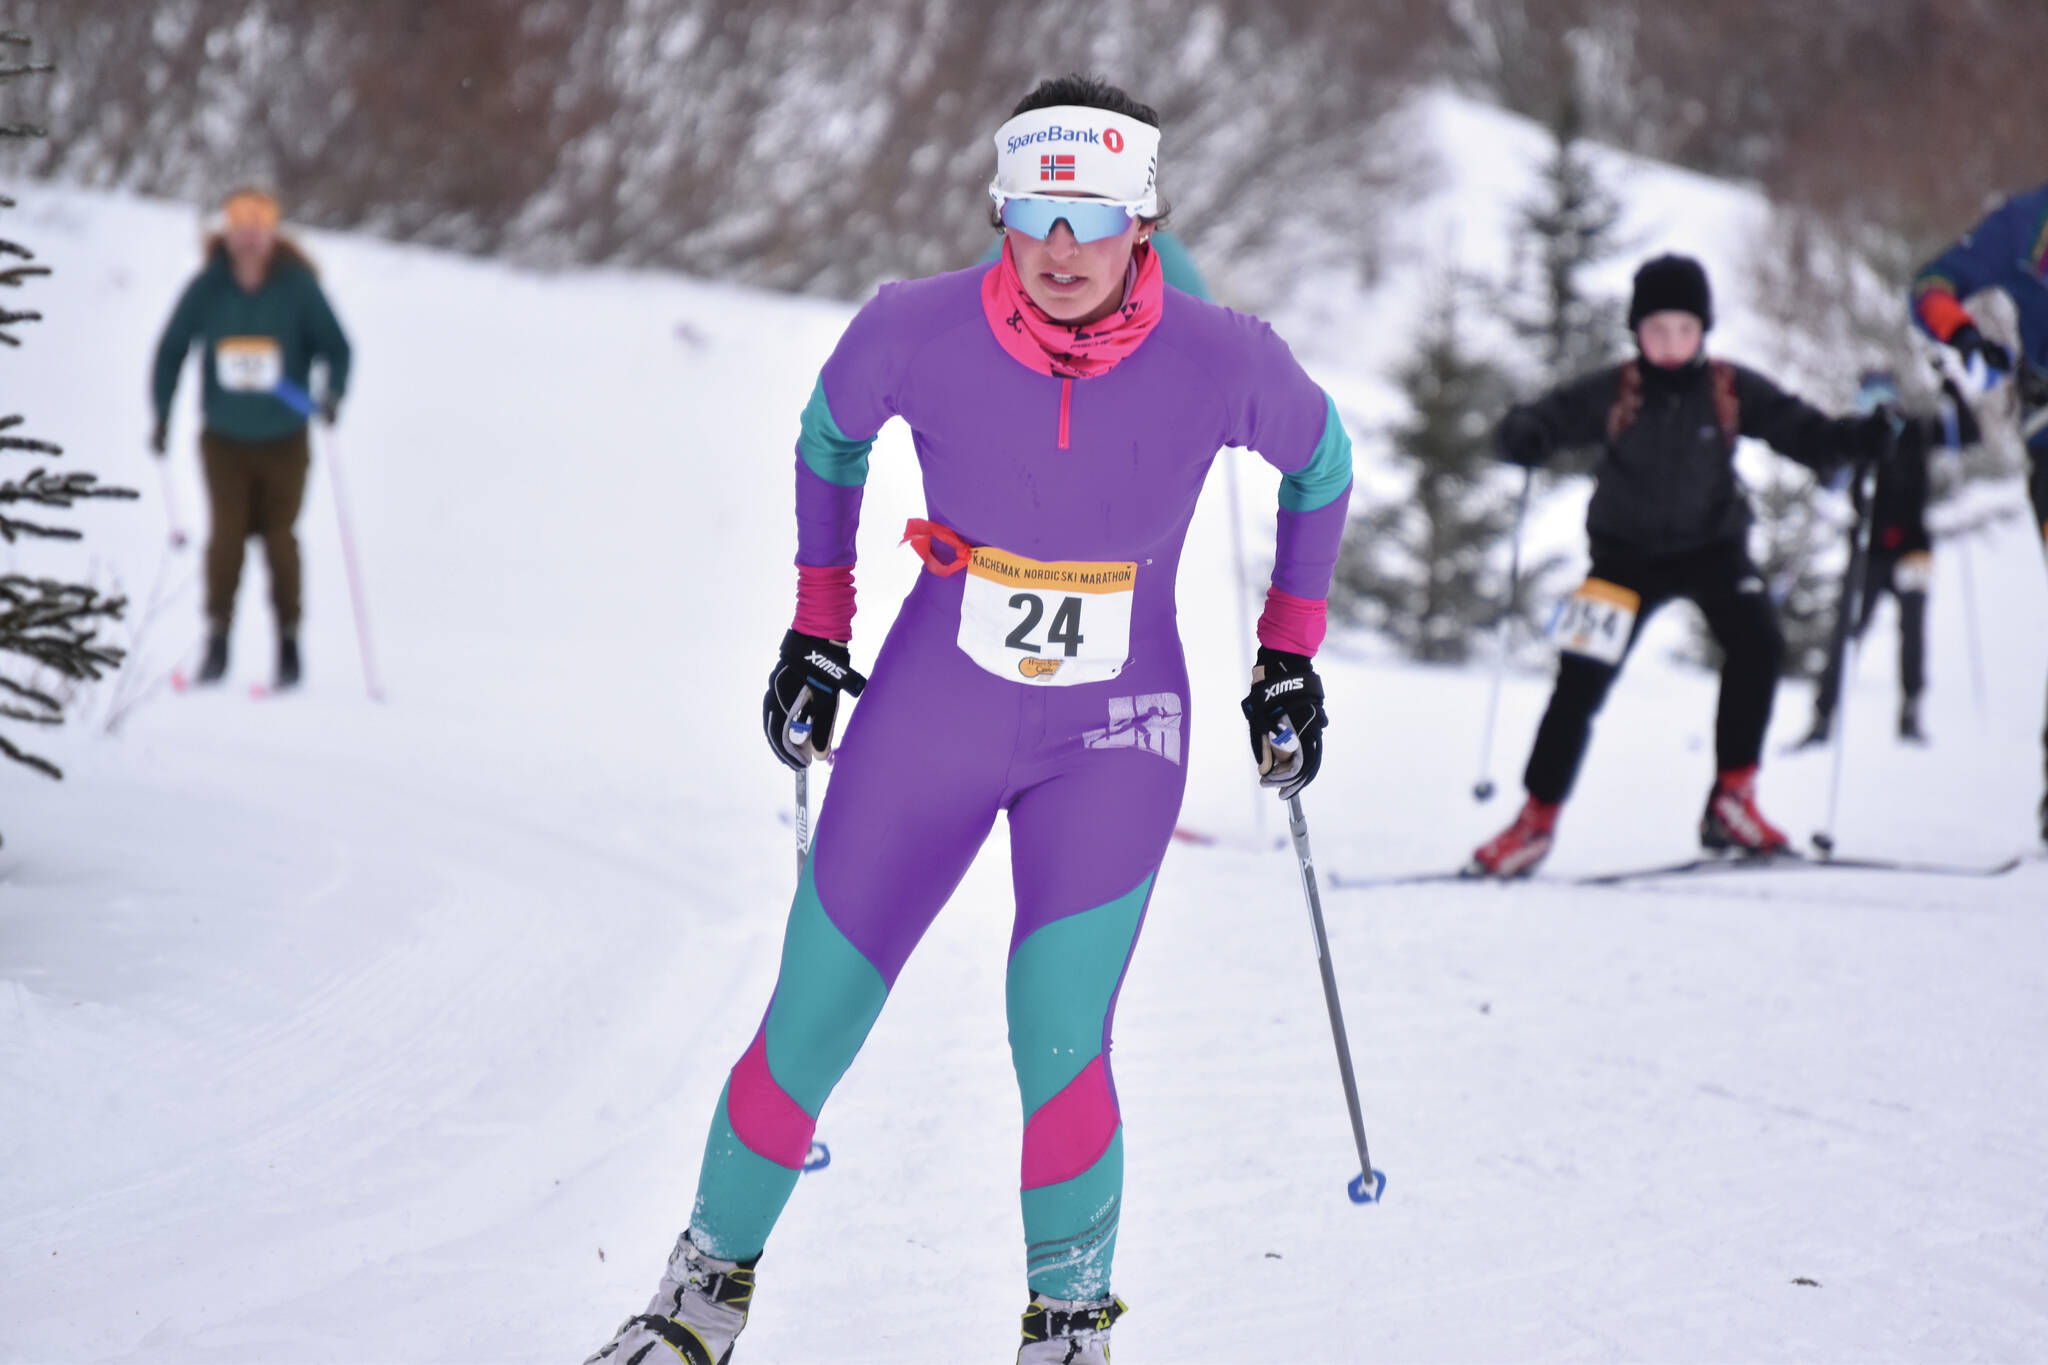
[154,244,348,442]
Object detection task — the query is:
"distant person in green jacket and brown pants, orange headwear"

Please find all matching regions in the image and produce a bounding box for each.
[150,188,348,688]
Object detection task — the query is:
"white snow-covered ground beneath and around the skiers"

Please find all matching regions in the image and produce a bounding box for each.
[0,98,2048,1365]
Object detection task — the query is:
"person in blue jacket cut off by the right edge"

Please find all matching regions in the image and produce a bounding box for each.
[1913,184,2048,843]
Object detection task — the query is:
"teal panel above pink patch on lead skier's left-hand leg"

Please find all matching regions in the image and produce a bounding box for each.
[768,860,889,1119]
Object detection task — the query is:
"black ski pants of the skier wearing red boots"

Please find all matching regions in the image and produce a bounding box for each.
[1522,540,1784,804]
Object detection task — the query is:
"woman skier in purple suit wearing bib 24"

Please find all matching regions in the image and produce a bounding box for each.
[592,76,1352,1365]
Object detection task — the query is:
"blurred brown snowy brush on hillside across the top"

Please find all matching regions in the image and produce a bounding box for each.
[10,0,2048,305]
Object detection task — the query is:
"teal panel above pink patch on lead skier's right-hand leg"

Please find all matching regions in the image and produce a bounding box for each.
[1008,876,1153,1119]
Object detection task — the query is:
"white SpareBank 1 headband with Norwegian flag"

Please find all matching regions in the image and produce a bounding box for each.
[989,104,1159,217]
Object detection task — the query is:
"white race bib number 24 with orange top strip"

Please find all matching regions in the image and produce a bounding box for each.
[961,544,1139,688]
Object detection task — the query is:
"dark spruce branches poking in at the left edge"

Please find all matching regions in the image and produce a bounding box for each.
[0,33,135,843]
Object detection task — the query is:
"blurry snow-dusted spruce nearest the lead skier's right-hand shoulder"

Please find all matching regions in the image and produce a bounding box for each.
[1331,291,1536,663]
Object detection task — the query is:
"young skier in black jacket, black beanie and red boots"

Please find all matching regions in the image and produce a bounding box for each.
[1468,256,1901,878]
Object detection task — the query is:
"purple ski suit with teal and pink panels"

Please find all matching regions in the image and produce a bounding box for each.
[690,268,1352,1300]
